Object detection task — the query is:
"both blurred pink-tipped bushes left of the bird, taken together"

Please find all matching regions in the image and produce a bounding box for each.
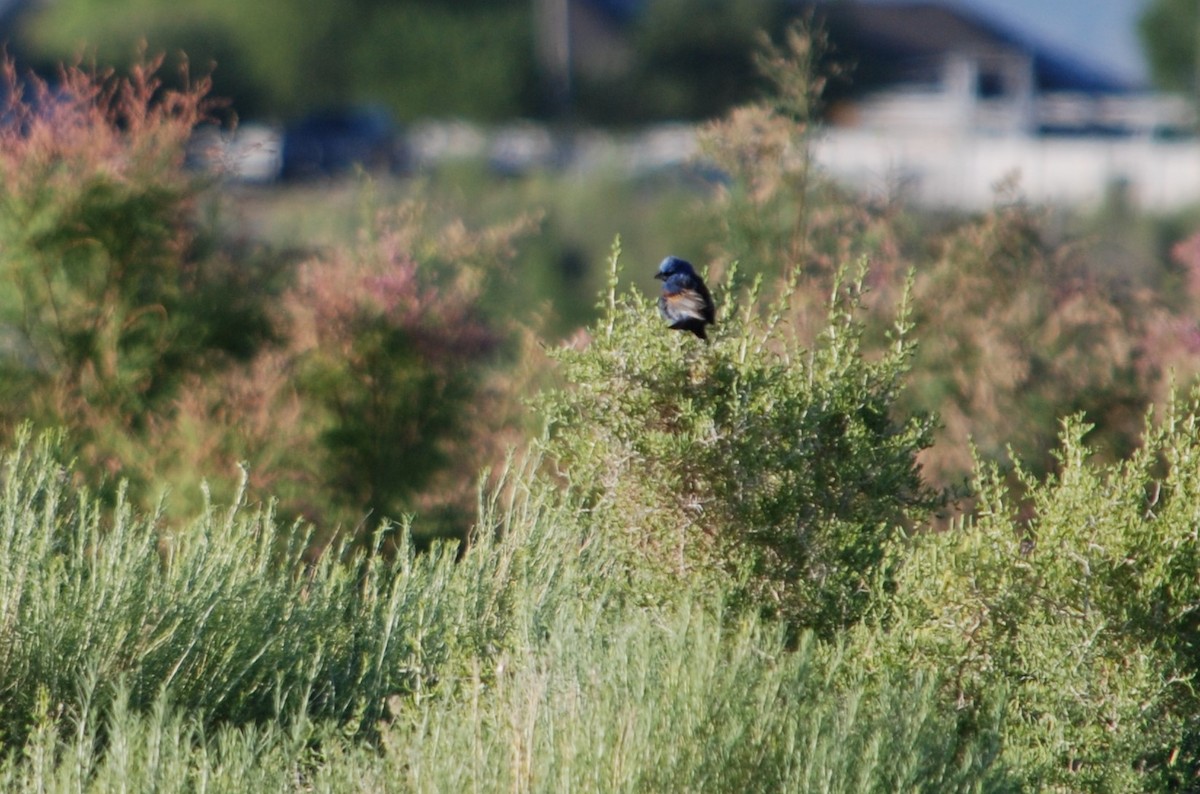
[0,61,530,534]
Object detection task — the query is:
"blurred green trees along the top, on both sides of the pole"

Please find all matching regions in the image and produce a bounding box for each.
[19,0,787,124]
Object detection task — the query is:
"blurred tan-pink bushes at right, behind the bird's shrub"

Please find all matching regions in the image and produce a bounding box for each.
[701,28,1200,487]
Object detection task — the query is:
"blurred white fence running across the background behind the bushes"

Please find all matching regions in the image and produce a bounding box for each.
[210,122,1200,211]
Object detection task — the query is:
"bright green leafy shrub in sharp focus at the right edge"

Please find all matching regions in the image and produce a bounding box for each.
[868,403,1200,792]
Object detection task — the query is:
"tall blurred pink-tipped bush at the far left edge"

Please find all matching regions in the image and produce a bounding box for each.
[0,60,290,509]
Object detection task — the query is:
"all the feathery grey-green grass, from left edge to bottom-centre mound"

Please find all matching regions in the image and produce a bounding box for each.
[0,422,1002,792]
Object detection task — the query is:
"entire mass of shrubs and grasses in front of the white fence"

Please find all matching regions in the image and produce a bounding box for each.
[0,32,1200,793]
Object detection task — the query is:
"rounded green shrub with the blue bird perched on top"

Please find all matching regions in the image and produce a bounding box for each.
[541,239,937,633]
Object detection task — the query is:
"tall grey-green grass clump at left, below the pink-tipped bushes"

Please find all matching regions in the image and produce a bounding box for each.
[0,431,556,741]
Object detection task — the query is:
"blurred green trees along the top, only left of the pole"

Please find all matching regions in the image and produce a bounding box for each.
[16,0,534,119]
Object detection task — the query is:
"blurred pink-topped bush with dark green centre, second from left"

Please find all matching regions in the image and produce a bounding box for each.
[138,201,533,545]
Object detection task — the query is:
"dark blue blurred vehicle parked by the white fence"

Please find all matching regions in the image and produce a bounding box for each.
[282,107,408,180]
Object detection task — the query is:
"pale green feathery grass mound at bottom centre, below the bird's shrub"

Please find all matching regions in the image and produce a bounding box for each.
[385,606,1003,792]
